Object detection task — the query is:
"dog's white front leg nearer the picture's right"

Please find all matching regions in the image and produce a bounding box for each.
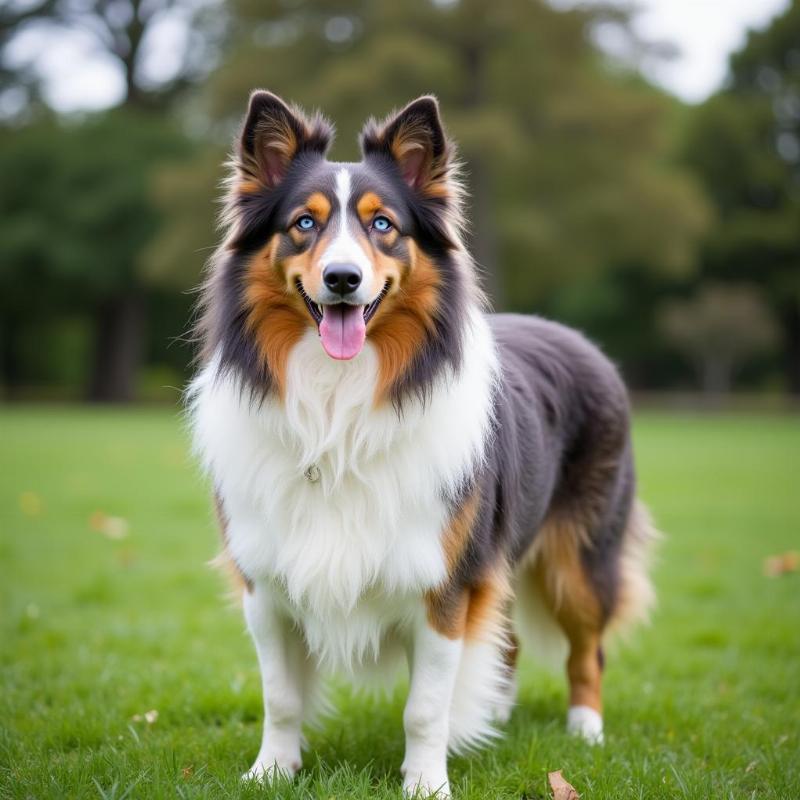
[401,619,463,798]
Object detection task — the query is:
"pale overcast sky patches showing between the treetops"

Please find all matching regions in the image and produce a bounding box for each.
[8,0,790,112]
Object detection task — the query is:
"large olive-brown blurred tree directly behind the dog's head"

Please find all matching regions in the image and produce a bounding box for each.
[150,0,707,310]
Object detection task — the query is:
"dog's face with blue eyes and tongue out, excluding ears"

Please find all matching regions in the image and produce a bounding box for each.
[247,154,418,360]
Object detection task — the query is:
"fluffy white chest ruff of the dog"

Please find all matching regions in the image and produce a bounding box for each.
[190,312,497,669]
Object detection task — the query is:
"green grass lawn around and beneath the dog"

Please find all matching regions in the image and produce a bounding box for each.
[0,408,800,800]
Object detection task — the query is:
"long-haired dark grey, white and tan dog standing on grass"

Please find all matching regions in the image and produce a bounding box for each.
[189,91,654,797]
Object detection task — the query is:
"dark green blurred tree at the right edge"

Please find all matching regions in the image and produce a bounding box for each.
[684,0,800,394]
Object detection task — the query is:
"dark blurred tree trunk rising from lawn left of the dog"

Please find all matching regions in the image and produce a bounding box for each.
[88,291,145,403]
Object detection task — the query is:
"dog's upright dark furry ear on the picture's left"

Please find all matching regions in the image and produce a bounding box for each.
[239,90,333,191]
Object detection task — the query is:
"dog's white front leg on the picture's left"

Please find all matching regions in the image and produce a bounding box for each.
[243,584,310,780]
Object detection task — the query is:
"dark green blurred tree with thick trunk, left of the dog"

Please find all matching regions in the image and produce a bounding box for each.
[0,109,187,400]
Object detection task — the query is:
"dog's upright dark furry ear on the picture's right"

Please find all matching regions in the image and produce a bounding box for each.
[361,95,453,196]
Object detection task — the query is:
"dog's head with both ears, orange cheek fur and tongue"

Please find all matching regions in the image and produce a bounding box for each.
[219,92,468,400]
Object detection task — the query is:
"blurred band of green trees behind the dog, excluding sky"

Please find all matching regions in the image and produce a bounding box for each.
[0,0,800,401]
